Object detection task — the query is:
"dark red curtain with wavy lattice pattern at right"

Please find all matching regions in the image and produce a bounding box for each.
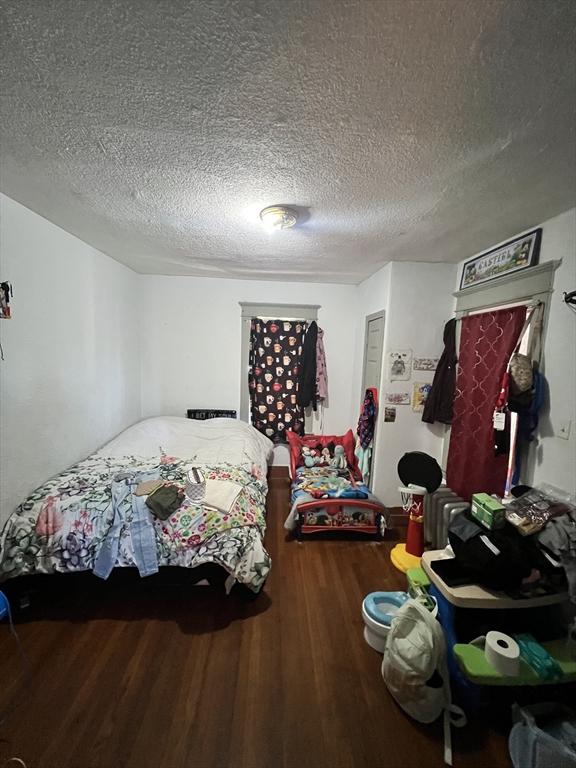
[446,306,526,501]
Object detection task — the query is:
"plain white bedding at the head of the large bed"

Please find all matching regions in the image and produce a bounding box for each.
[97,416,273,475]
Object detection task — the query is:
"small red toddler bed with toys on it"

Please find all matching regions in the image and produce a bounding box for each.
[284,430,388,538]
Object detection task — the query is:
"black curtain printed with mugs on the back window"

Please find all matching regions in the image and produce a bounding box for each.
[248,317,307,443]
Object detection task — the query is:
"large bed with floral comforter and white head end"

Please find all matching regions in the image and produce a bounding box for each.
[0,417,273,593]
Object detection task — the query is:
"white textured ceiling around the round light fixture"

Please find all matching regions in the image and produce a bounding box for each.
[0,0,576,283]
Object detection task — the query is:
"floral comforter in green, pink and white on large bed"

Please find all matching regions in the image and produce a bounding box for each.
[0,454,270,592]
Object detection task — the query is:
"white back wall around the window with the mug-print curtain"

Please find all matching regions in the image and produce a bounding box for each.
[140,275,357,464]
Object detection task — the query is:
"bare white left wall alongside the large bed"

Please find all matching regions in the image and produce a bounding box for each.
[0,195,140,524]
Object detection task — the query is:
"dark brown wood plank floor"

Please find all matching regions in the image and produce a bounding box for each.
[0,480,510,768]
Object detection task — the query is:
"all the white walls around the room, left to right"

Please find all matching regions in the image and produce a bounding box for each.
[0,191,576,522]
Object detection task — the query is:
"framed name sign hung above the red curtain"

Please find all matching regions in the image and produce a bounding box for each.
[460,228,542,290]
